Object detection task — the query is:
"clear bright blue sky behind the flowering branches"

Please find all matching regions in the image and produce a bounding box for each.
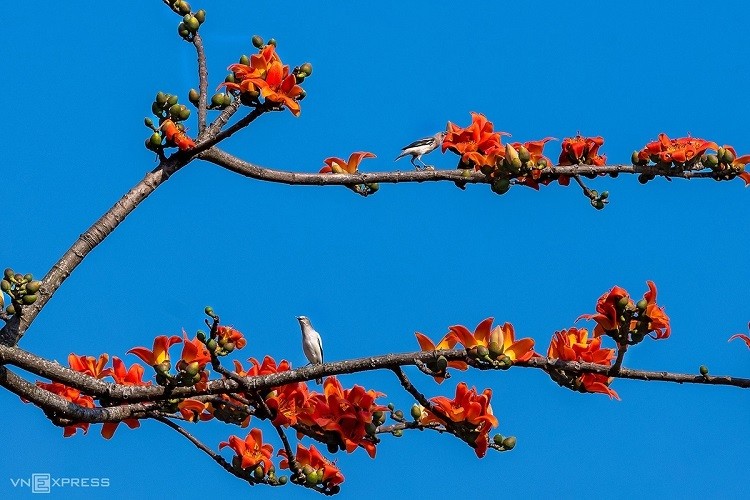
[0,0,750,498]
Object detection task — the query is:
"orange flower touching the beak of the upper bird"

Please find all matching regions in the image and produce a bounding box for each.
[442,112,510,168]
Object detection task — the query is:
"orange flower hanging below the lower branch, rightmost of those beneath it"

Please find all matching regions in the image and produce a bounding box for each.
[420,382,498,458]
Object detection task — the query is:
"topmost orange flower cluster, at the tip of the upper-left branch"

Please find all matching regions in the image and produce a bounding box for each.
[220,36,312,116]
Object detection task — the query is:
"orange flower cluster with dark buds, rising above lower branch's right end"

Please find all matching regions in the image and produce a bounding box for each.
[579,281,670,345]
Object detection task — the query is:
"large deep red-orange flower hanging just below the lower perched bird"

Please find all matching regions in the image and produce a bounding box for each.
[298,377,386,458]
